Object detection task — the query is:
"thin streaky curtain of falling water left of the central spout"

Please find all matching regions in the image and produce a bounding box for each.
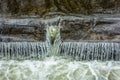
[0,42,47,60]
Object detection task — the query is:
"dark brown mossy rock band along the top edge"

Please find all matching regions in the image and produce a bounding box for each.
[0,0,120,17]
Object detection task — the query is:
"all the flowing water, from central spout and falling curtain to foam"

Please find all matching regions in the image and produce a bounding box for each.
[0,21,120,80]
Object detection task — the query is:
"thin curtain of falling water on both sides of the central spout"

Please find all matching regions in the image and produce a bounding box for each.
[0,41,120,61]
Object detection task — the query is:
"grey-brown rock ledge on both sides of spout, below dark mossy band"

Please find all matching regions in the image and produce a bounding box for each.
[0,15,120,41]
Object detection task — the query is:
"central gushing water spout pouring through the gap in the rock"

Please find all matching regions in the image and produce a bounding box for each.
[46,25,61,56]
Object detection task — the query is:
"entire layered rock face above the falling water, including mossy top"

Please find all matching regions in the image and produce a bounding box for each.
[0,0,120,42]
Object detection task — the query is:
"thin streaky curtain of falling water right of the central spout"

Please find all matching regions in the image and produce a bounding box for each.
[60,41,120,61]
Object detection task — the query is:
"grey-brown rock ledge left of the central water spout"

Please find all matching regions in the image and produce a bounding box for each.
[0,19,45,41]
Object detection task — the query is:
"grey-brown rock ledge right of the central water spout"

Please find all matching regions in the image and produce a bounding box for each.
[61,18,120,40]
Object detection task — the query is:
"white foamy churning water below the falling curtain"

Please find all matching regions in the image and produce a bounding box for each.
[0,57,120,80]
